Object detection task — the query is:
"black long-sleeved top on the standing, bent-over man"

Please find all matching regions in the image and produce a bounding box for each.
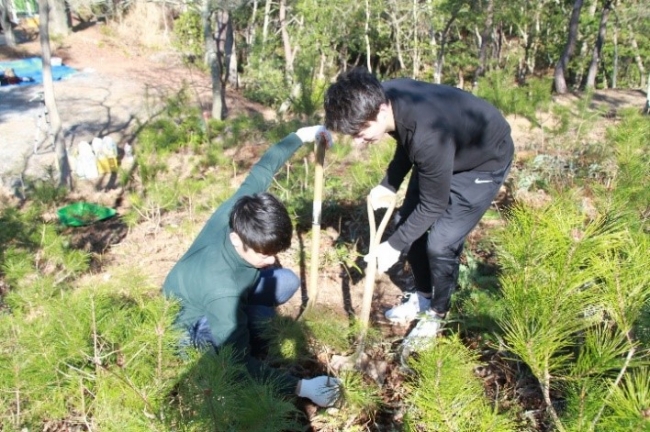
[381,79,514,250]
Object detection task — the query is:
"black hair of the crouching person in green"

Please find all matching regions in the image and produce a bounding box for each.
[229,192,293,255]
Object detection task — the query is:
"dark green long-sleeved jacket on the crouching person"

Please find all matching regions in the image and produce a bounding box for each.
[163,134,302,391]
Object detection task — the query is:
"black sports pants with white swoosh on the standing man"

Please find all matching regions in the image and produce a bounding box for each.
[397,157,511,314]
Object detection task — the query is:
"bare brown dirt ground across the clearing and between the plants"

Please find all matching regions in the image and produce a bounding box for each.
[0,21,645,432]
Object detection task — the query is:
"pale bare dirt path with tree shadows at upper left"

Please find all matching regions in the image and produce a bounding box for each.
[0,26,216,190]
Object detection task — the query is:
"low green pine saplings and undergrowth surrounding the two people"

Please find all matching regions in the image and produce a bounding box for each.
[0,89,650,431]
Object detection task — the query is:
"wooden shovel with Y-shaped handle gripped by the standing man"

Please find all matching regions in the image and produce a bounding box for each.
[357,197,397,358]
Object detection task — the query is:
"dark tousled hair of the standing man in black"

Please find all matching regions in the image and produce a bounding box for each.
[324,67,388,135]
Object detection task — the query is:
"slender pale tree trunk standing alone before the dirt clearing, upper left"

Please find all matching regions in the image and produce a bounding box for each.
[38,0,72,188]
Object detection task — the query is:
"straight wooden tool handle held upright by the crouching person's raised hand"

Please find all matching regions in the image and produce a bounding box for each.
[307,133,327,309]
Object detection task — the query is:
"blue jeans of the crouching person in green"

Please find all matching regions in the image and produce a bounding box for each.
[186,267,300,349]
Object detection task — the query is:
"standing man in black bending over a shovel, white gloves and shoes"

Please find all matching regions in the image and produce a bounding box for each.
[325,68,514,352]
